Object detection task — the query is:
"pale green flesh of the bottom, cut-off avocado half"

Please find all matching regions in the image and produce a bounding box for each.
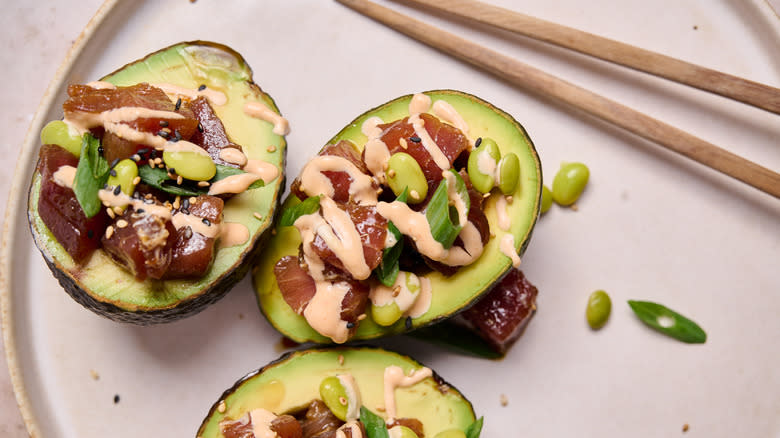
[197,348,475,438]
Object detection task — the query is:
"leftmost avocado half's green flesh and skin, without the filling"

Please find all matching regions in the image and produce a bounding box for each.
[28,41,287,325]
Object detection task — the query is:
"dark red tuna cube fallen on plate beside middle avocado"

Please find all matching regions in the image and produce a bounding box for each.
[458,269,539,354]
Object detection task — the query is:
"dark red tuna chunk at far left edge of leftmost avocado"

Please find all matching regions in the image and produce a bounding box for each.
[38,144,109,264]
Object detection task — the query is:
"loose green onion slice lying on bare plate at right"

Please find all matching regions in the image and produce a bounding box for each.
[628,300,707,344]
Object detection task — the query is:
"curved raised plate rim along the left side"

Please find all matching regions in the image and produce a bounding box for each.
[0,0,119,438]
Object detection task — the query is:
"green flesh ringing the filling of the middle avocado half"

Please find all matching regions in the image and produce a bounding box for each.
[253,90,542,343]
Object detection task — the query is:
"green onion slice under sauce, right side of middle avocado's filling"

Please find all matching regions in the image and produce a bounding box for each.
[425,171,471,248]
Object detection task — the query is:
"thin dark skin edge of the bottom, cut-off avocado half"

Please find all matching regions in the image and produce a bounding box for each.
[196,345,474,437]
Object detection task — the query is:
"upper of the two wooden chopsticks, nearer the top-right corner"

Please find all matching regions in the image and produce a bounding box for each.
[396,0,780,114]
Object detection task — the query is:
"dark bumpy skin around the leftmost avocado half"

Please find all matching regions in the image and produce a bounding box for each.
[28,41,287,325]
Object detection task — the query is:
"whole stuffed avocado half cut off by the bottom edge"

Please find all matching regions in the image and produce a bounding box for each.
[197,347,482,438]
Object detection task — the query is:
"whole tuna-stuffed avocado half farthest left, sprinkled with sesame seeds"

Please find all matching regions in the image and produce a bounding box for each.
[28,41,288,324]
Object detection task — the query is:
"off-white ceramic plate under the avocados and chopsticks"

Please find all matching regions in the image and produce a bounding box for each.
[2,0,780,438]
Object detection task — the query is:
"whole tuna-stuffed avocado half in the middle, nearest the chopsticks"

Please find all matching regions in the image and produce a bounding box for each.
[253,90,542,343]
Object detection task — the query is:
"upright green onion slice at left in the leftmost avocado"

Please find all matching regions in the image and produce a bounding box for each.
[73,134,109,218]
